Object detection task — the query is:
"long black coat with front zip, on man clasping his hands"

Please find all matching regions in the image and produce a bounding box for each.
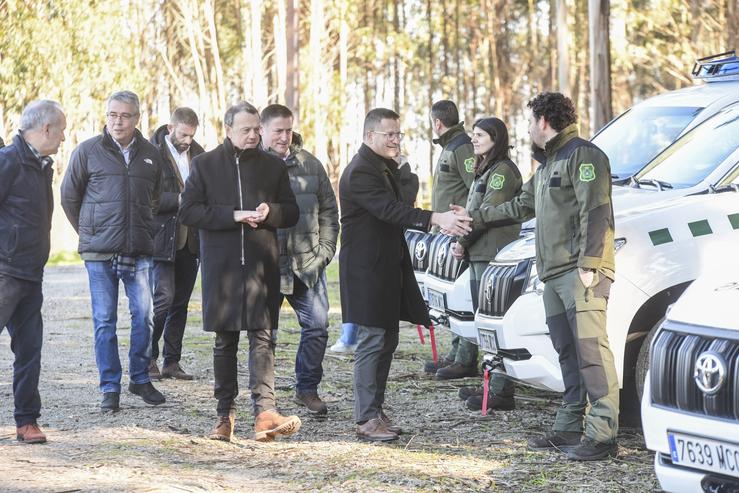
[180,138,298,331]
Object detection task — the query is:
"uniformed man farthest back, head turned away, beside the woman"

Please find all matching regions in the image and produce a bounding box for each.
[424,99,477,380]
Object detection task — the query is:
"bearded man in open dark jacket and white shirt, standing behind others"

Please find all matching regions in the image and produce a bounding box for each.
[149,107,204,380]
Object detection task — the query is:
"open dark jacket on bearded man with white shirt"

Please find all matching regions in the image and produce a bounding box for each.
[151,125,205,262]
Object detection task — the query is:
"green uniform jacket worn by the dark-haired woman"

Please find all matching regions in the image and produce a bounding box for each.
[458,159,523,263]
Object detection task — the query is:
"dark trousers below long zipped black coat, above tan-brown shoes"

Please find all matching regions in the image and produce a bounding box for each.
[213,329,276,417]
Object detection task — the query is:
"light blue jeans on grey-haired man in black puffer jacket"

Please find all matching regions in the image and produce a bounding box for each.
[85,257,154,392]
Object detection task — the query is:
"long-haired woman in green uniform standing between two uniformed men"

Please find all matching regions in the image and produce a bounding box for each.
[451,118,523,411]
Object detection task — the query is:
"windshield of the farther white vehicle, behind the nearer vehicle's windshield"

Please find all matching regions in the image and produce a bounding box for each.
[593,106,703,178]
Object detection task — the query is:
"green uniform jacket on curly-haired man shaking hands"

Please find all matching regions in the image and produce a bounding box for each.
[471,124,615,281]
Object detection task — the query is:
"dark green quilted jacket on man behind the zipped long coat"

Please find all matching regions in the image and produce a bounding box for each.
[277,133,339,294]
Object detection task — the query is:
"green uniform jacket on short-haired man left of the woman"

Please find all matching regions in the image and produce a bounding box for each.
[431,122,475,212]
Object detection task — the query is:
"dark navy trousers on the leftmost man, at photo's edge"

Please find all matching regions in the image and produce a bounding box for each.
[0,274,44,426]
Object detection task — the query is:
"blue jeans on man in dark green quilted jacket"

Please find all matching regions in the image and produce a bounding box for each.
[280,272,328,394]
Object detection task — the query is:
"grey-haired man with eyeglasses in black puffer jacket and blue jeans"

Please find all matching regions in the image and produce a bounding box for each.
[61,91,165,412]
